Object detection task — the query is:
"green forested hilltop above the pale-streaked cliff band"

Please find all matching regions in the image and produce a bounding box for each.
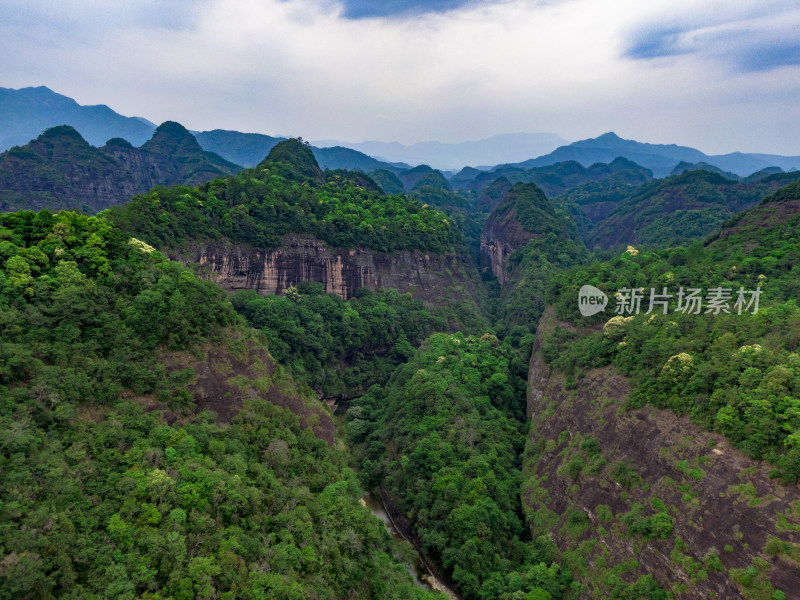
[106,140,461,252]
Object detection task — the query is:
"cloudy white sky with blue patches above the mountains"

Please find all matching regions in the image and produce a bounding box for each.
[0,0,800,155]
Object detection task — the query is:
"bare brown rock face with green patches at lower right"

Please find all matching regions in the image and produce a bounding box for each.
[522,308,800,598]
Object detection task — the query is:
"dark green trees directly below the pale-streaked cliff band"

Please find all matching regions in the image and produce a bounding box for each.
[232,282,448,396]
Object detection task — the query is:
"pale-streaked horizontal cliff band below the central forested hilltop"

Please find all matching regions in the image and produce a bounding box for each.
[171,234,474,303]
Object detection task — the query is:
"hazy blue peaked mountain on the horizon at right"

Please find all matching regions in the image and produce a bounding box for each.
[506,132,800,177]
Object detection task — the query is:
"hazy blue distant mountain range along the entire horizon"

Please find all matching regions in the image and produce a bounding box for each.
[0,86,800,178]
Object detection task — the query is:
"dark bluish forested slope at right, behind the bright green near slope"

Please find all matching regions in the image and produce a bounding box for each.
[586,171,800,249]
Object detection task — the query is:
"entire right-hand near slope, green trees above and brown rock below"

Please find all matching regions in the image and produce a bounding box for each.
[523,183,800,598]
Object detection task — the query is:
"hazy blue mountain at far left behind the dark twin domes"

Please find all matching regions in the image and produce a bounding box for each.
[0,86,155,151]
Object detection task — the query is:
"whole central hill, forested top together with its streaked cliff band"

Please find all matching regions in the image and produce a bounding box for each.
[108,140,476,303]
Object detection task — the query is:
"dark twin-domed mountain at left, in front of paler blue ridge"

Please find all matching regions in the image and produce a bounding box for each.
[0,121,241,213]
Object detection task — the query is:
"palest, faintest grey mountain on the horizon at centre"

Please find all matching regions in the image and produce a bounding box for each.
[314,133,566,171]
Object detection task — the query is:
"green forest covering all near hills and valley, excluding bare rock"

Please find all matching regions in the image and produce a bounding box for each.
[0,140,800,600]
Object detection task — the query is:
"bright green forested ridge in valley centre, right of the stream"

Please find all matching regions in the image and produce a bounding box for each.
[348,334,570,599]
